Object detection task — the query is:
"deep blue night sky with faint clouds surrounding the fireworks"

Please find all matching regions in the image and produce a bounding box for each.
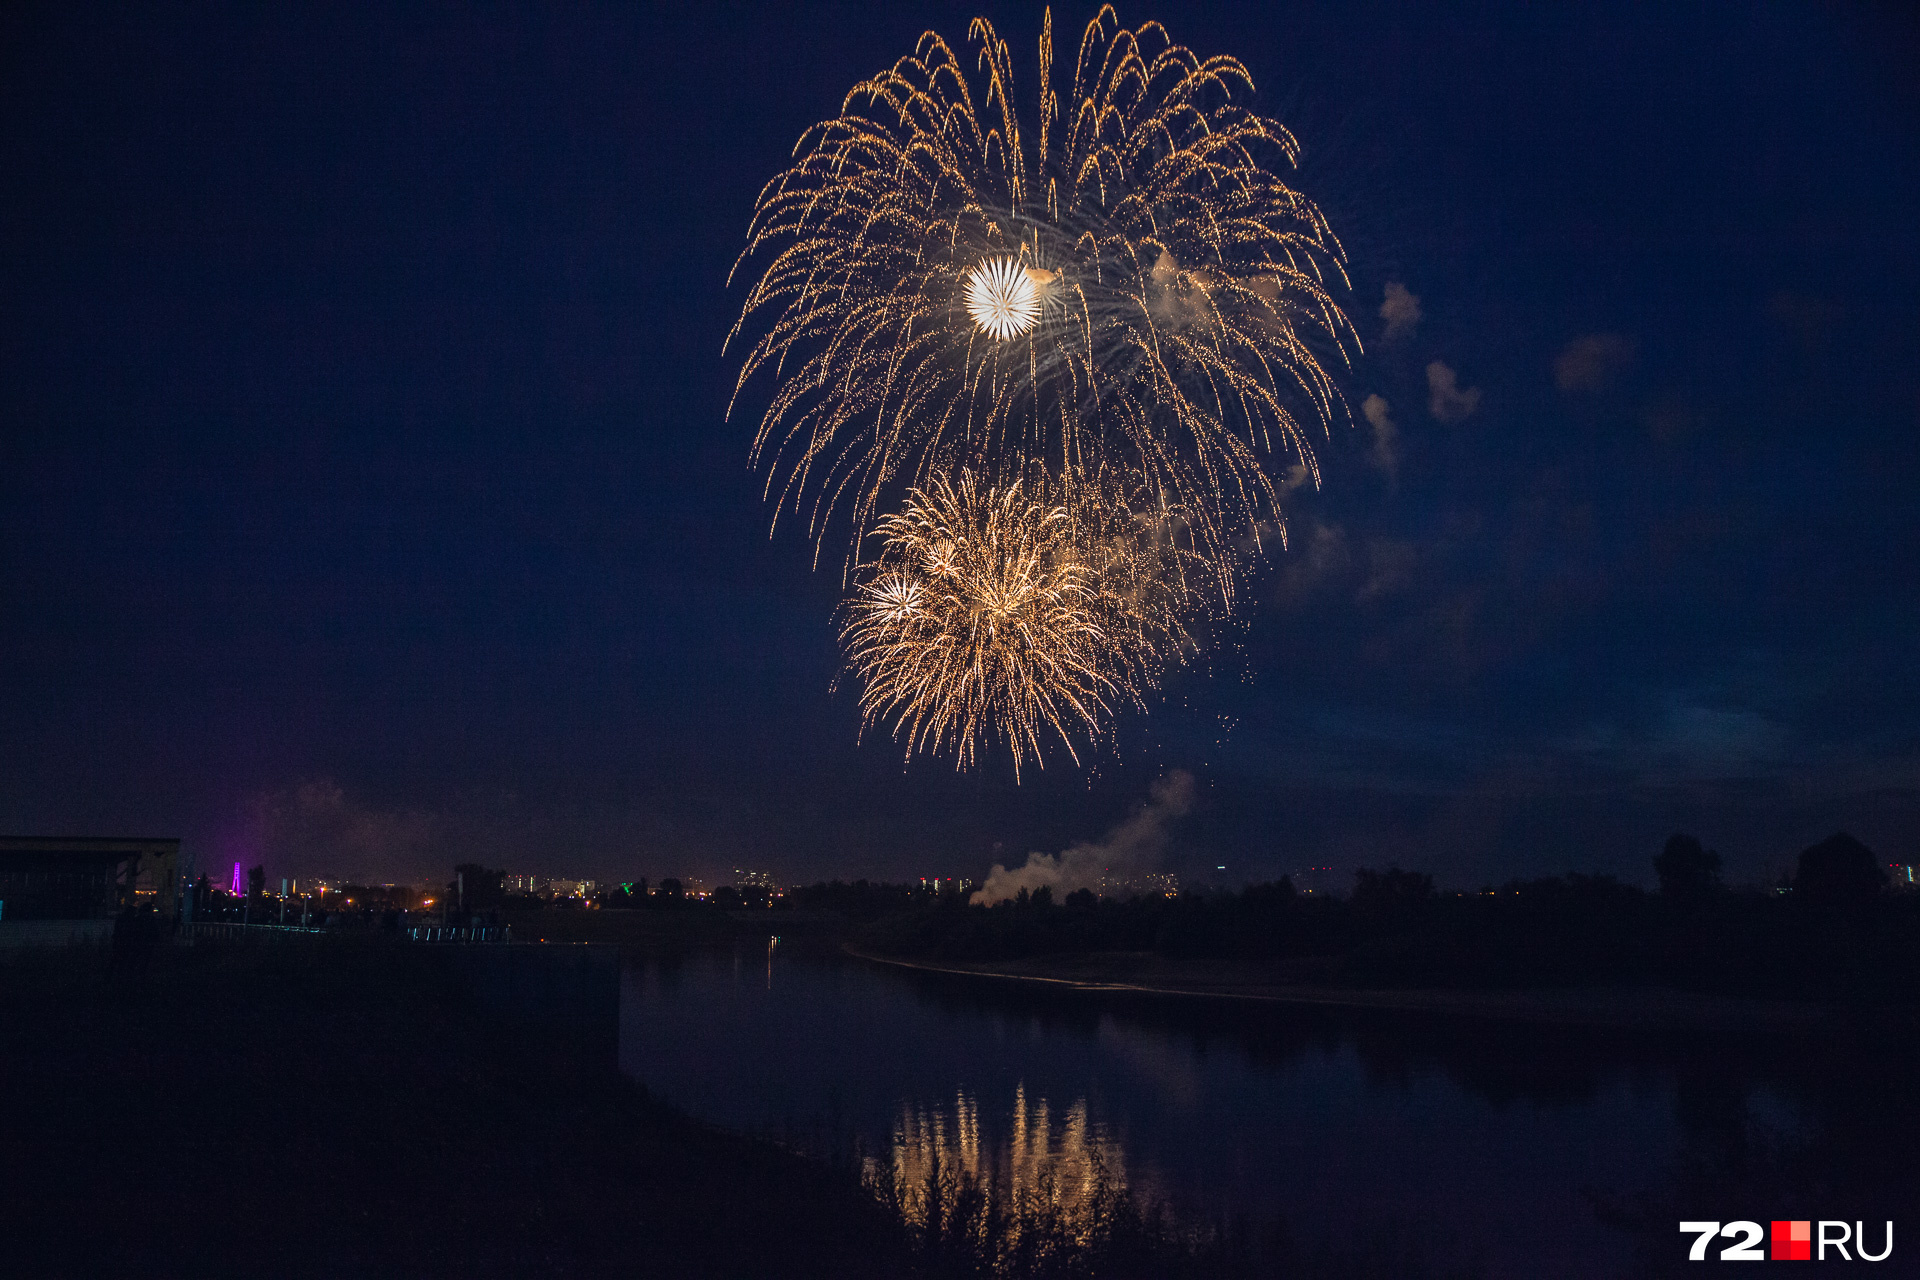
[0,0,1920,887]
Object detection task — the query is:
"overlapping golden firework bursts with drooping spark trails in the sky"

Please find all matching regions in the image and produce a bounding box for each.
[728,8,1357,768]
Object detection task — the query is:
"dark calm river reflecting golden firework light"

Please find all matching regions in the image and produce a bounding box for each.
[620,940,1850,1276]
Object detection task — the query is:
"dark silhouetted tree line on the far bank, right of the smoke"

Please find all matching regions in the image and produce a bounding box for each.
[860,835,1920,1002]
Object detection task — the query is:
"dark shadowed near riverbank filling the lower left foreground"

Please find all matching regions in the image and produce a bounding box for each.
[0,940,910,1278]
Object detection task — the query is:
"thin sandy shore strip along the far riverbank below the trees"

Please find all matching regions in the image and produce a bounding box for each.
[847,946,1830,1032]
